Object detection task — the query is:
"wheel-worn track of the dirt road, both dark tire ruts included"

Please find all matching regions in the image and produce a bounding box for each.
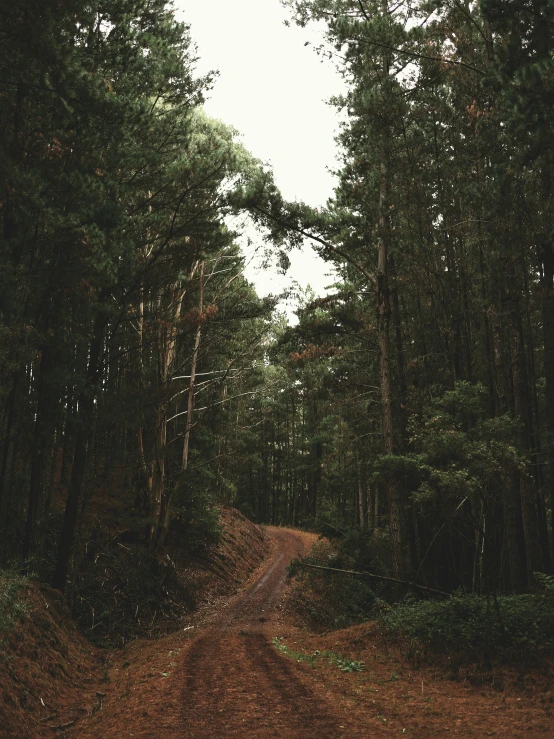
[180,531,344,739]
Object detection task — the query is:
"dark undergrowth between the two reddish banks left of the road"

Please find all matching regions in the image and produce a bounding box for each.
[67,498,221,646]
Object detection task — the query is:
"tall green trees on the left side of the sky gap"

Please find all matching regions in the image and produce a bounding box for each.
[0,0,273,600]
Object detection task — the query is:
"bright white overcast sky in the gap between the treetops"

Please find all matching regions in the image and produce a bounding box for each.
[175,0,343,312]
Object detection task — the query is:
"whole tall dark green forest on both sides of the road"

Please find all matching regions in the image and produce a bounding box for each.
[0,0,554,652]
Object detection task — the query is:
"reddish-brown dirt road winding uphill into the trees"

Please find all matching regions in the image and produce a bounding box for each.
[72,529,362,739]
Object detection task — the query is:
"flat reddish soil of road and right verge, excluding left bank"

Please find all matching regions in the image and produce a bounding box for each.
[0,528,554,739]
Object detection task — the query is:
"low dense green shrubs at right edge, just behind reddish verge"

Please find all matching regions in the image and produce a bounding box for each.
[380,592,554,660]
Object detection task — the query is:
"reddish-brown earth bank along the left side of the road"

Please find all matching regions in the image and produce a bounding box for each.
[0,509,268,739]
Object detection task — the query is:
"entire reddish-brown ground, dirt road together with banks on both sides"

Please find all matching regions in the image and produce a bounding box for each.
[4,528,554,739]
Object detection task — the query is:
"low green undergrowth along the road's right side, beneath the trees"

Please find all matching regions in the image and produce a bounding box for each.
[289,536,554,670]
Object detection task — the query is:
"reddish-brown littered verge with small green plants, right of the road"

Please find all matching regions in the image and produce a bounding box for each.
[279,622,554,739]
